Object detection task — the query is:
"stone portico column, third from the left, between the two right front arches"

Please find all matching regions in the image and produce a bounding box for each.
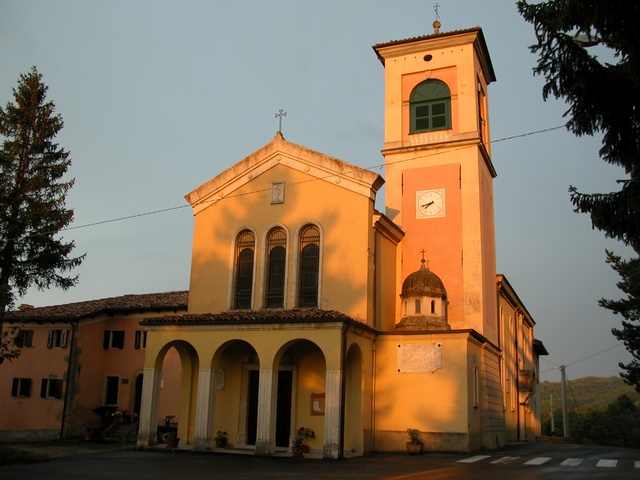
[256,370,278,456]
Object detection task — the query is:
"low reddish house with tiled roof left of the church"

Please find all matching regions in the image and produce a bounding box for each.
[0,291,188,441]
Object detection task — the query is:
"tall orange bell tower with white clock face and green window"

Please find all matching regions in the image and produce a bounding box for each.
[373,21,498,340]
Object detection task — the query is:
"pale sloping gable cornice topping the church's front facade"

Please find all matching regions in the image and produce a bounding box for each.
[185,132,384,213]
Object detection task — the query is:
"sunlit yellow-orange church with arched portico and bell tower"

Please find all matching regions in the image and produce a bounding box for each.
[138,25,546,459]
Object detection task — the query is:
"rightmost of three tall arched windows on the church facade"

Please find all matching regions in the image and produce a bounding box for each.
[298,225,320,307]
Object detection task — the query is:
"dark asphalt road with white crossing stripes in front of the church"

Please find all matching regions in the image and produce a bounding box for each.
[0,442,640,480]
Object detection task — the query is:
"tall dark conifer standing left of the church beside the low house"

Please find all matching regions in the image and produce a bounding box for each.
[0,67,84,361]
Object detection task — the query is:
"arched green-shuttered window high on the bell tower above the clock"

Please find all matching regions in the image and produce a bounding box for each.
[410,80,451,133]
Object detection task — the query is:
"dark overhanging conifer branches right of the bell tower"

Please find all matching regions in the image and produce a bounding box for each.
[518,0,640,389]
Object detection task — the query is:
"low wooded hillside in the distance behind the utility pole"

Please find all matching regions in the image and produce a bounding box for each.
[538,376,640,420]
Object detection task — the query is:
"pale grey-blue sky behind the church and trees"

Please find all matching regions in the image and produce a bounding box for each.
[0,0,631,381]
